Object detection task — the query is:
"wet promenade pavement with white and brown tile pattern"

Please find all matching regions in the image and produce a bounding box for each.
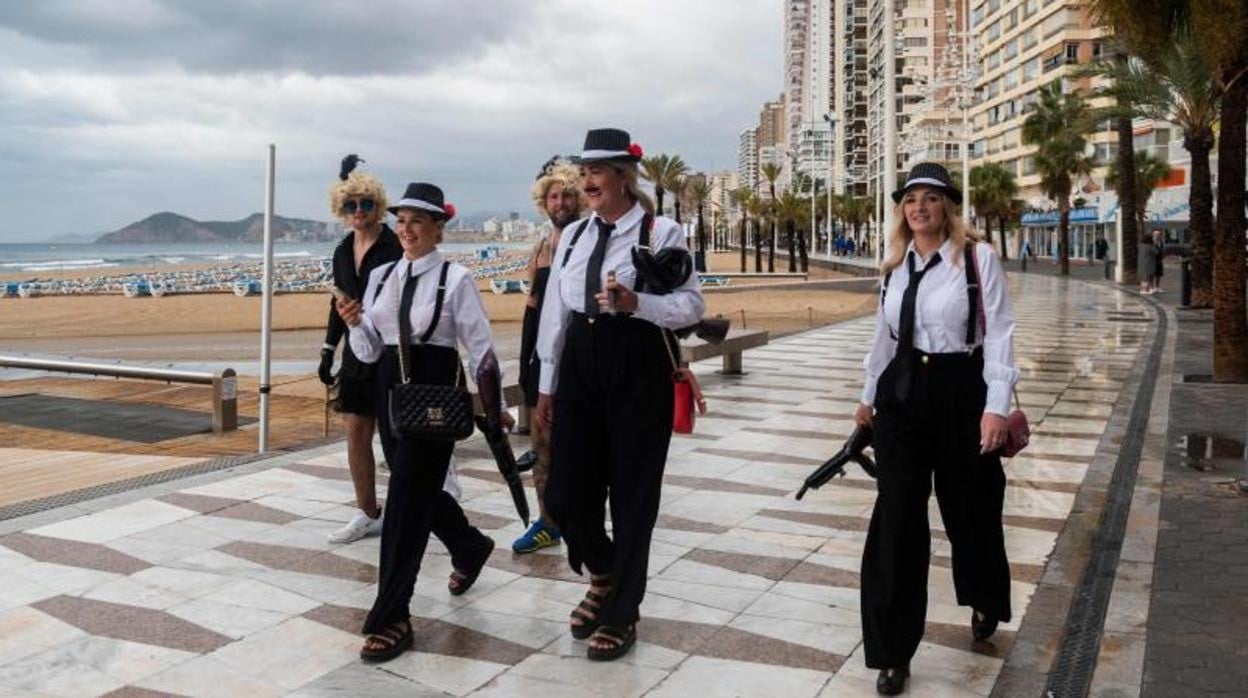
[0,275,1173,698]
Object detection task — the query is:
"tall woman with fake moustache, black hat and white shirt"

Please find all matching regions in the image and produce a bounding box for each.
[537,129,705,659]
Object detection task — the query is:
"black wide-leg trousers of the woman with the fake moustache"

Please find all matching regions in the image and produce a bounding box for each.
[547,313,673,627]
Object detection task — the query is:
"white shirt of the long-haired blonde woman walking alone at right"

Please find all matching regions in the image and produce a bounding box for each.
[862,240,1018,417]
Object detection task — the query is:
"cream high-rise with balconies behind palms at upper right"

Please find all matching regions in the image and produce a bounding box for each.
[971,0,1117,199]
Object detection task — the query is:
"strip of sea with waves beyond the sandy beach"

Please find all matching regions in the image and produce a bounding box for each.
[0,242,529,275]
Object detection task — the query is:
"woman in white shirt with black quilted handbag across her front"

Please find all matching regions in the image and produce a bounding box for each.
[337,184,512,662]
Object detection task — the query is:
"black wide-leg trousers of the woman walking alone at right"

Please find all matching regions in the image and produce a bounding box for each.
[861,351,1010,669]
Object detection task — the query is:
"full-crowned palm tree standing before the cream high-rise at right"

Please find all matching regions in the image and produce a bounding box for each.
[1022,80,1098,276]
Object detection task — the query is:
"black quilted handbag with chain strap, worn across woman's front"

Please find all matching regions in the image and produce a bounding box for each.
[387,262,474,441]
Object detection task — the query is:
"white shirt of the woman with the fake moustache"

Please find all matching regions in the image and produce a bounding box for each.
[537,204,706,395]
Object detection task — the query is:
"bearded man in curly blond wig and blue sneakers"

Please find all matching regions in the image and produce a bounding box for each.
[512,159,585,553]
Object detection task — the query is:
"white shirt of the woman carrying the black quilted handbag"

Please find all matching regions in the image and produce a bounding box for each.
[349,250,507,410]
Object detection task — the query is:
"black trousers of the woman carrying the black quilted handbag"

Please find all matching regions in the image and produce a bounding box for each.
[363,345,490,634]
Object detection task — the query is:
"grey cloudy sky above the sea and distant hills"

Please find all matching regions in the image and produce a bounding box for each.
[0,0,781,242]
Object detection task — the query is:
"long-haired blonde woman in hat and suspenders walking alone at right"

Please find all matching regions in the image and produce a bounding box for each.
[854,162,1018,696]
